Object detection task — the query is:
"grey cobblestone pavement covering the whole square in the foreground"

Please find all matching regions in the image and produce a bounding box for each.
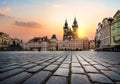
[0,51,120,84]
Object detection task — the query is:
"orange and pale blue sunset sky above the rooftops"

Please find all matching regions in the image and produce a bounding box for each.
[0,0,120,41]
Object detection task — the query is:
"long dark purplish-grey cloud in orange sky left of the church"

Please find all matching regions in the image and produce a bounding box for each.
[14,21,41,28]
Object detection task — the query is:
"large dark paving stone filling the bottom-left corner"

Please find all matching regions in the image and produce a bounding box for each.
[0,72,31,84]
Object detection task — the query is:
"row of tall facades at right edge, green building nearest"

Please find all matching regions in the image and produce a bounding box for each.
[95,10,120,51]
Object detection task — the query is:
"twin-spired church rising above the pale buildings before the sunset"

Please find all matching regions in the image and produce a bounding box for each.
[63,18,78,40]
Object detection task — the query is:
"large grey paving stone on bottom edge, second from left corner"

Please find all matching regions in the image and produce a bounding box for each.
[23,71,51,84]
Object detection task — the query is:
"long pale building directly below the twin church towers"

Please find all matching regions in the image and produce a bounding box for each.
[58,39,89,51]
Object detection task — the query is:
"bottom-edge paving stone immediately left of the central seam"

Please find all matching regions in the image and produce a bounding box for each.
[46,76,67,84]
